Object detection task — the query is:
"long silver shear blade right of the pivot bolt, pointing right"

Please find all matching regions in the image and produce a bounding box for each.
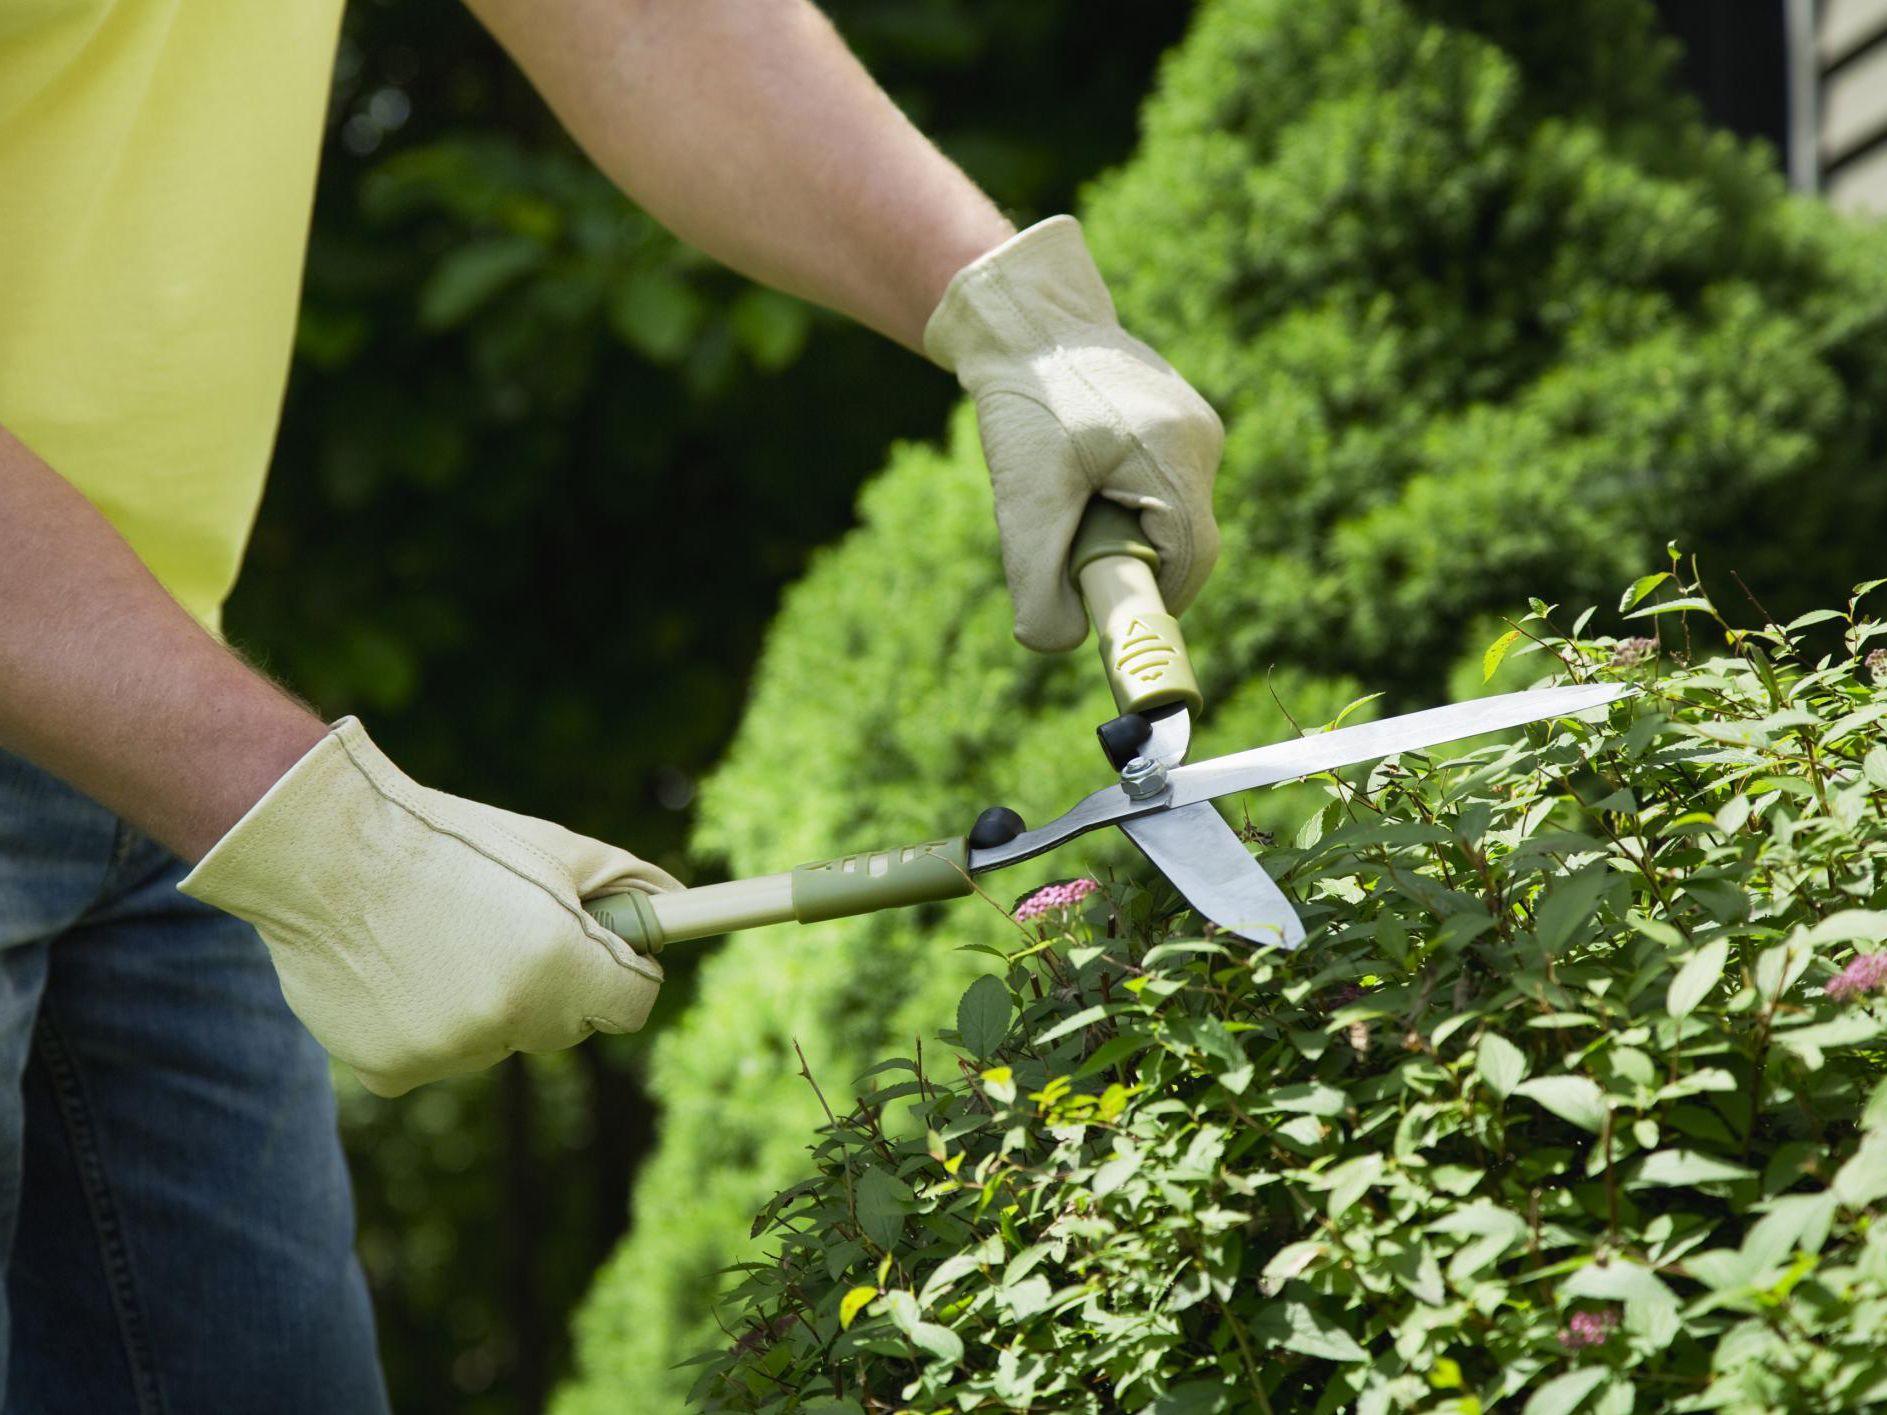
[1170,683,1630,806]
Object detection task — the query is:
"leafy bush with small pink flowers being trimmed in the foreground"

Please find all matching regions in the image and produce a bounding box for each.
[696,577,1887,1415]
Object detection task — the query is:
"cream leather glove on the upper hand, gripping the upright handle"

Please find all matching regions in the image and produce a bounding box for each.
[925,217,1225,651]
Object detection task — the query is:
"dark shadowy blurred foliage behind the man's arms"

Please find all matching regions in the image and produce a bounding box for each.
[228,0,1187,1415]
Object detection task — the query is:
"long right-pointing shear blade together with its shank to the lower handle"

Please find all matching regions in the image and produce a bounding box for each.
[970,683,1632,874]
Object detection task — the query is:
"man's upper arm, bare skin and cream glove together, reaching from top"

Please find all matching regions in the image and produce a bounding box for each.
[468,0,1225,649]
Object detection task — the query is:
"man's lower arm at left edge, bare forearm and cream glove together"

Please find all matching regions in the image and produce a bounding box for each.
[0,432,677,1094]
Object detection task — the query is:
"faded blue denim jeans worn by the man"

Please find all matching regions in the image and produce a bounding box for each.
[0,753,387,1415]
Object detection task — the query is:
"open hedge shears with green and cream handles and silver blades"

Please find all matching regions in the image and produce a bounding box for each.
[583,498,1628,953]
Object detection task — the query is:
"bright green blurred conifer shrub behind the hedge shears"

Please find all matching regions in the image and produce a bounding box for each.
[560,0,1887,1415]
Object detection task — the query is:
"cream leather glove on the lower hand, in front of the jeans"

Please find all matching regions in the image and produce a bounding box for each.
[179,717,679,1096]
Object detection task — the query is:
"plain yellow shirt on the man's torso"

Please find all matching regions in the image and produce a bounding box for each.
[0,0,342,628]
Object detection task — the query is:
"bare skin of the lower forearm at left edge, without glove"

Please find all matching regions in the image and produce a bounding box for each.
[0,430,325,858]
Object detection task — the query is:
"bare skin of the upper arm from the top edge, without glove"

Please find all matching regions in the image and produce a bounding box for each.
[470,0,1013,349]
